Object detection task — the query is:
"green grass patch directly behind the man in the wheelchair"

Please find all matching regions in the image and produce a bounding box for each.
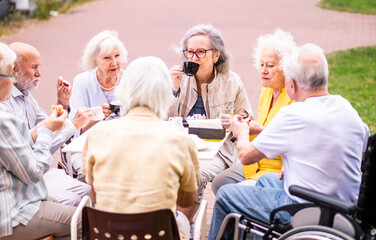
[327,46,376,133]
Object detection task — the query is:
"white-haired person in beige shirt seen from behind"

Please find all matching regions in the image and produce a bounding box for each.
[82,57,198,238]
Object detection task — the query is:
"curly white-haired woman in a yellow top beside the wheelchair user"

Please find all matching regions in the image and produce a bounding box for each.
[212,30,296,194]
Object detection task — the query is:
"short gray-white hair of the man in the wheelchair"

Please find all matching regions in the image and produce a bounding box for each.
[282,43,329,91]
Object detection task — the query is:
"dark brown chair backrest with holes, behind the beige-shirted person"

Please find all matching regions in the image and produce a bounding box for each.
[82,206,180,240]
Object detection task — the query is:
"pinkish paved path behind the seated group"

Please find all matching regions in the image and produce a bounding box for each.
[0,0,376,236]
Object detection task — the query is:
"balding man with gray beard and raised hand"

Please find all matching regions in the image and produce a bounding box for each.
[0,42,94,206]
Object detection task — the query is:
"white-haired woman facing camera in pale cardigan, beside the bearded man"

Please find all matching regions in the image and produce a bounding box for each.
[68,30,128,180]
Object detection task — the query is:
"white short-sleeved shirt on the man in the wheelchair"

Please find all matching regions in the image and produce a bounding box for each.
[252,95,369,204]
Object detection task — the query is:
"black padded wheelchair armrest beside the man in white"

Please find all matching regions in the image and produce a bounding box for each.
[289,185,356,214]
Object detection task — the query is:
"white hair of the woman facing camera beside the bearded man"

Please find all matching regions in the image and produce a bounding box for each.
[81,30,128,71]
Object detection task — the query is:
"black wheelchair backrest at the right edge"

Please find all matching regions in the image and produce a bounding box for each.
[357,134,376,227]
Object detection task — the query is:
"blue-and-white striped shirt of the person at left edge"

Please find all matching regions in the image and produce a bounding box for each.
[0,107,53,237]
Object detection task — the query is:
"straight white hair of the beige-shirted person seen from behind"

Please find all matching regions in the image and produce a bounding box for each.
[116,57,172,119]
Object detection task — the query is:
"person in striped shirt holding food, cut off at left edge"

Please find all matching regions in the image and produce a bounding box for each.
[0,42,81,239]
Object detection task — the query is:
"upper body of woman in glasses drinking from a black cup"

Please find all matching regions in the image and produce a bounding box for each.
[169,24,253,119]
